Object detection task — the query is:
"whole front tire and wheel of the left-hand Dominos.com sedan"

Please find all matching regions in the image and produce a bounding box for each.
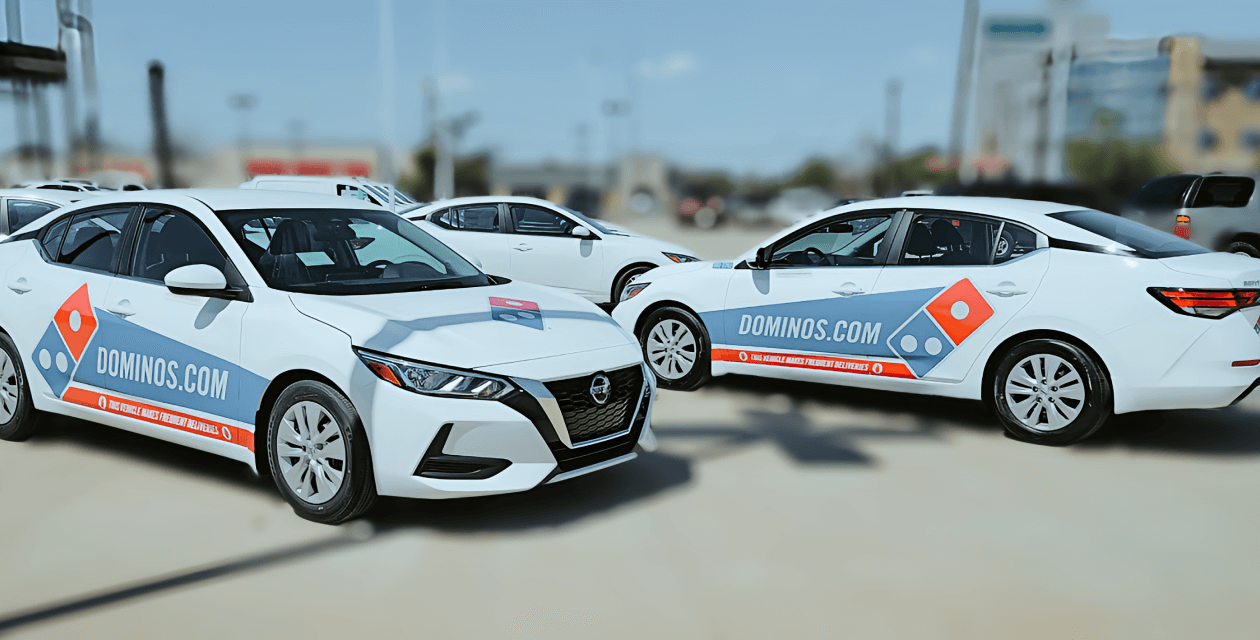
[267,380,377,524]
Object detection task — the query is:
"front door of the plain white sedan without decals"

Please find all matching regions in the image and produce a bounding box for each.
[508,204,611,302]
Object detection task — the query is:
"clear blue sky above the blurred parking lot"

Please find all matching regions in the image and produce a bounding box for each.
[0,0,1260,176]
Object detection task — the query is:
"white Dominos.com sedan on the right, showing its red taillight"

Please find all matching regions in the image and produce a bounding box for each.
[612,197,1260,445]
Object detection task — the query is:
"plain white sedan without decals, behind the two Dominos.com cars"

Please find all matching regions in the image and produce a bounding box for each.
[402,195,697,304]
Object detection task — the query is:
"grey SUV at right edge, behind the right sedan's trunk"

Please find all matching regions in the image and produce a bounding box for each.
[1120,174,1260,258]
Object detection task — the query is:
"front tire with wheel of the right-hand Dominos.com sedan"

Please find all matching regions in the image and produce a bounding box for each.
[639,306,711,391]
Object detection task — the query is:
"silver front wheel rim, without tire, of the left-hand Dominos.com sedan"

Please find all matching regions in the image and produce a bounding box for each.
[276,401,347,504]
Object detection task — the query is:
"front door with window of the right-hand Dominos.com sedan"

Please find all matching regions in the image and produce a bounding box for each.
[703,210,898,379]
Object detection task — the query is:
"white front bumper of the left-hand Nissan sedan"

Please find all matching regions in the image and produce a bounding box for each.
[365,362,655,499]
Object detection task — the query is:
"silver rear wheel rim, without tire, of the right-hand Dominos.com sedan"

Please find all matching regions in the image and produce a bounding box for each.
[1005,354,1085,432]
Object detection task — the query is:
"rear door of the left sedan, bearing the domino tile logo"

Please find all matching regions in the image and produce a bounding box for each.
[4,205,134,402]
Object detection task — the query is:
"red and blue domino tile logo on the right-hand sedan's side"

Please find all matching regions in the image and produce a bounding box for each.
[888,280,993,378]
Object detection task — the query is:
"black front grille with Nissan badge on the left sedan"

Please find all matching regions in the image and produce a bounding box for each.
[544,365,643,446]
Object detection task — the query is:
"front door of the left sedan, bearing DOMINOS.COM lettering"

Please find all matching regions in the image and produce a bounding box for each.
[82,205,263,457]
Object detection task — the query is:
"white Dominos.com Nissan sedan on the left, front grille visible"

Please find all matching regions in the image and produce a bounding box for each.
[0,190,655,523]
